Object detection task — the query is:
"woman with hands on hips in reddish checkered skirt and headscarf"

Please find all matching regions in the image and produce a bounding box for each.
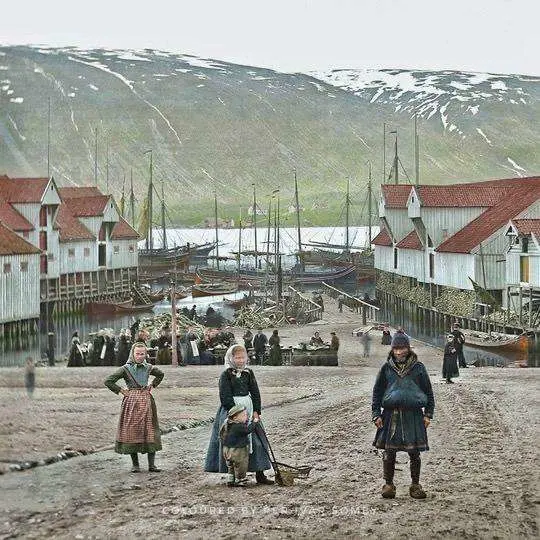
[105,342,163,473]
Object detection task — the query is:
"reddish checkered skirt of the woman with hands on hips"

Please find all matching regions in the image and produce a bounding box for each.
[114,389,161,454]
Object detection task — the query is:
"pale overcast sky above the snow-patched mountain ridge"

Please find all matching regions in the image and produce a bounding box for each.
[4,0,540,75]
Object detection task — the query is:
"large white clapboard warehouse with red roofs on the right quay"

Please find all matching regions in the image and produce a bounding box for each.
[373,177,540,305]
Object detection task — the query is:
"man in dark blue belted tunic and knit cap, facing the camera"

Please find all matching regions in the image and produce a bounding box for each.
[371,333,435,499]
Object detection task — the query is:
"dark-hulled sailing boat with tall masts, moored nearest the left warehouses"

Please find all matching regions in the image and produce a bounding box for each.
[136,150,216,278]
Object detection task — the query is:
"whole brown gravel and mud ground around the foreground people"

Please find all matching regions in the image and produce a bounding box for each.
[0,298,540,539]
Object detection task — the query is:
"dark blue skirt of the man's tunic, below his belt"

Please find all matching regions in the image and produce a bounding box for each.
[373,409,429,452]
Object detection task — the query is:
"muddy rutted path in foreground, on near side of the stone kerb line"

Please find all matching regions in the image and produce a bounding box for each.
[0,360,539,538]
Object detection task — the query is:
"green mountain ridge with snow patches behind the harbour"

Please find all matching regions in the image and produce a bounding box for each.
[0,46,540,226]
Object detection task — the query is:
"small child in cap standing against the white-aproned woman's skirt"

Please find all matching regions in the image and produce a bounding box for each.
[220,405,259,487]
